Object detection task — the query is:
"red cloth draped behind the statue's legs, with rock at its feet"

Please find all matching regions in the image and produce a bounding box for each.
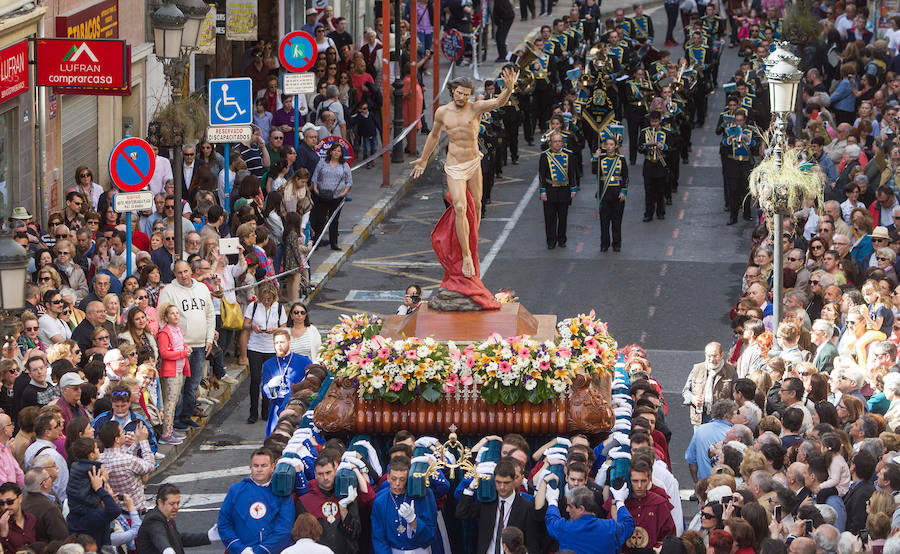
[431,188,500,311]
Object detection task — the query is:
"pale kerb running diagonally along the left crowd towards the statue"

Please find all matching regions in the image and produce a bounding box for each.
[307,135,448,300]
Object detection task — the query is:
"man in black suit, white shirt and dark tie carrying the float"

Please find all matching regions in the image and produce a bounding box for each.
[456,457,544,554]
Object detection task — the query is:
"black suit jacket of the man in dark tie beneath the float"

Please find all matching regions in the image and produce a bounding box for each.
[456,493,544,554]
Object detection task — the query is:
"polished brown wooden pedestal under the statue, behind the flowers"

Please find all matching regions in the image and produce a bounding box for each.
[381,300,556,342]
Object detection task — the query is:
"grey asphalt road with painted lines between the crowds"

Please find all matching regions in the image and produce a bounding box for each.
[148,8,752,540]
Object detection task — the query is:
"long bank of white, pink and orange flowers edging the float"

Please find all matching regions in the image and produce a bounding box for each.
[321,312,616,405]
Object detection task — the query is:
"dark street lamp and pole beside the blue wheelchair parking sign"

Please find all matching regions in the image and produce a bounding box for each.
[150,0,209,258]
